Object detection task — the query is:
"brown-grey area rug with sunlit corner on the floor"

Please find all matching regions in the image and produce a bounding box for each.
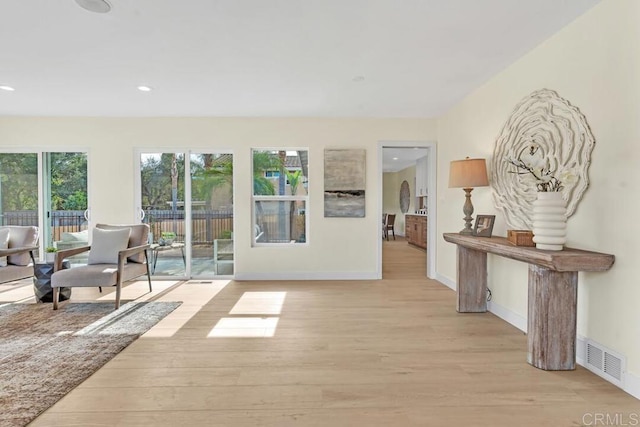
[0,302,181,426]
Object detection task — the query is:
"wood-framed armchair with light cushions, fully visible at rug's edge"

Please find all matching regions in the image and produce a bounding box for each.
[51,224,152,310]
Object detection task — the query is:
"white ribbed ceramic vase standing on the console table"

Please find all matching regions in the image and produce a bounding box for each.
[533,191,567,251]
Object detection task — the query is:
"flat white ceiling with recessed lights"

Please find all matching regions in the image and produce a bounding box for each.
[0,0,598,117]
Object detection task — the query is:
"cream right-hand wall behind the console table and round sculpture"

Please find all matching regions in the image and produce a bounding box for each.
[437,0,640,391]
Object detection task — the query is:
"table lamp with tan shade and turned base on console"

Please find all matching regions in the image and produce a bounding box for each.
[449,157,489,234]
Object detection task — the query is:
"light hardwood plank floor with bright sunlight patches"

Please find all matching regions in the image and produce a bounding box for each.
[32,239,640,426]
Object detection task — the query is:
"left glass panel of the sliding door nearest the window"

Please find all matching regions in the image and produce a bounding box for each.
[140,152,188,277]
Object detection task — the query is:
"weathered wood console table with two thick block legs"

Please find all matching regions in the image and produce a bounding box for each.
[444,233,615,371]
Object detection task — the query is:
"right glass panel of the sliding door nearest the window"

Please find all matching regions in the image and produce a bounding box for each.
[190,153,234,277]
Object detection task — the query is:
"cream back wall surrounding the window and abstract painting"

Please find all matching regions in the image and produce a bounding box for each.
[0,117,436,279]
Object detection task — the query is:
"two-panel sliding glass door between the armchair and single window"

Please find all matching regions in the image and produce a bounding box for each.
[138,151,234,278]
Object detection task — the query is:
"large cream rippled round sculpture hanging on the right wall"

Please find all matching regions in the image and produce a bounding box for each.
[491,89,595,229]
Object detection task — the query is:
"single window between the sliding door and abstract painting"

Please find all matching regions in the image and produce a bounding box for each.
[252,149,309,246]
